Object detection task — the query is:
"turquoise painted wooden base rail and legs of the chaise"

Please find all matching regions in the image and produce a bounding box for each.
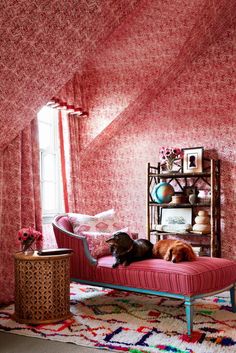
[72,278,236,336]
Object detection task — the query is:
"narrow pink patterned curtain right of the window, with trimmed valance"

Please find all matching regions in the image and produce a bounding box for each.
[51,73,85,212]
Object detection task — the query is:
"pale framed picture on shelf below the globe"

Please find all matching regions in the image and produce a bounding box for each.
[161,207,193,225]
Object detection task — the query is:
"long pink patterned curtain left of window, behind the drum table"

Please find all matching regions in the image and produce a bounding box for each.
[0,118,42,303]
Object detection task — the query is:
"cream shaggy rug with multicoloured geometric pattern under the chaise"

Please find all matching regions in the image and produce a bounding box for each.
[0,283,236,353]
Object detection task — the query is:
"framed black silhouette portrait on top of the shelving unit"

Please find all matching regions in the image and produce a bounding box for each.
[182,147,203,173]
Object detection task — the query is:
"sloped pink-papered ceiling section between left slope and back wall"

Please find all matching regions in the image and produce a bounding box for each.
[80,0,236,154]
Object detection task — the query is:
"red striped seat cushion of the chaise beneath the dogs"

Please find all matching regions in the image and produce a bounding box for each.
[95,256,236,295]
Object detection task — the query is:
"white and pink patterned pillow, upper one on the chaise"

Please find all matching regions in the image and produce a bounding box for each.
[68,209,122,234]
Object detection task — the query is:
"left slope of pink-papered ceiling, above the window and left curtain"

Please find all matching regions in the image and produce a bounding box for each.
[0,0,140,149]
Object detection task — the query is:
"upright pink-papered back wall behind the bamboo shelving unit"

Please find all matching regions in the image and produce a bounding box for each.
[81,17,236,258]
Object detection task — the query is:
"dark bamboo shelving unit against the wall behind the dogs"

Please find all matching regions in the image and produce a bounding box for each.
[147,158,221,257]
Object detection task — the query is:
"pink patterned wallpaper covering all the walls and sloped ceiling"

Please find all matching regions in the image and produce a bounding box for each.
[0,0,236,264]
